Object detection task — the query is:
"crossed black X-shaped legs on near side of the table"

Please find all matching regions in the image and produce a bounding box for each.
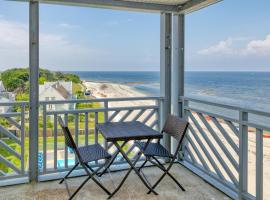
[108,140,158,199]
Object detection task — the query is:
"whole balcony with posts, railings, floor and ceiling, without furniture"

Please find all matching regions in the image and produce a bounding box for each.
[0,0,270,200]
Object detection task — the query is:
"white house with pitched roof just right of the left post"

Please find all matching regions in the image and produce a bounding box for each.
[39,81,75,110]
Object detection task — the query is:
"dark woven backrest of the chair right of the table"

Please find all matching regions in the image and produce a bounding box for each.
[162,115,189,142]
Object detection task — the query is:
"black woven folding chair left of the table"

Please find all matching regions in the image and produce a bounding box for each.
[58,117,111,199]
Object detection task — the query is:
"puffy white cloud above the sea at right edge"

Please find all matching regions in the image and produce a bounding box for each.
[198,35,270,56]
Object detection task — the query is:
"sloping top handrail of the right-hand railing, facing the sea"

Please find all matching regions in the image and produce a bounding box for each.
[179,96,270,117]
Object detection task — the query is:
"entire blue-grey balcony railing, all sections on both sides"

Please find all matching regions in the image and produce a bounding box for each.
[0,97,270,199]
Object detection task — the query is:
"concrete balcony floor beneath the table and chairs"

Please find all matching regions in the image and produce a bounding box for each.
[0,164,230,200]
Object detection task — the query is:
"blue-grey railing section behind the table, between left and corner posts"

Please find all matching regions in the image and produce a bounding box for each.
[39,97,160,180]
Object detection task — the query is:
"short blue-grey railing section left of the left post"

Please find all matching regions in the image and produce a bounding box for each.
[0,102,28,186]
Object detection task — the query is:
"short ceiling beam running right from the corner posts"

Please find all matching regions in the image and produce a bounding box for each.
[177,0,222,14]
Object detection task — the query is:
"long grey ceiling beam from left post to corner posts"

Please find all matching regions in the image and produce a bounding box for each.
[13,0,179,12]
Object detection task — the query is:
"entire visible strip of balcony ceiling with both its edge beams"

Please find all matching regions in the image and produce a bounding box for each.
[10,0,222,14]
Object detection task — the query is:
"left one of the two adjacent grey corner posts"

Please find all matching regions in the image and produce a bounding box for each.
[160,13,172,153]
